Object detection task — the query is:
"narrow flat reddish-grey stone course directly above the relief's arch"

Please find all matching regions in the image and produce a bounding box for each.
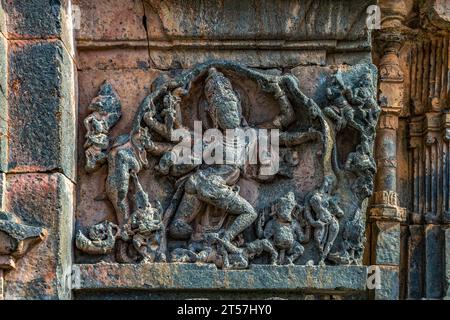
[79,42,328,70]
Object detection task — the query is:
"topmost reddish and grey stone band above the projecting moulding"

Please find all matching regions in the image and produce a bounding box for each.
[74,0,375,41]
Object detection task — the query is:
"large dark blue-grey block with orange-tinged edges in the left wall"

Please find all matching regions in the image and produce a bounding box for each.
[8,40,75,179]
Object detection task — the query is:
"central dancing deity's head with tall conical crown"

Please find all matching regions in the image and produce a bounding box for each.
[205,68,241,130]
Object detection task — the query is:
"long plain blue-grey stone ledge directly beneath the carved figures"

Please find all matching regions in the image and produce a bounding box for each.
[72,263,384,293]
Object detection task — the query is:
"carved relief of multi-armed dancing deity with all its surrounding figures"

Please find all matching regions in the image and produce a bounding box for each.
[76,61,379,269]
